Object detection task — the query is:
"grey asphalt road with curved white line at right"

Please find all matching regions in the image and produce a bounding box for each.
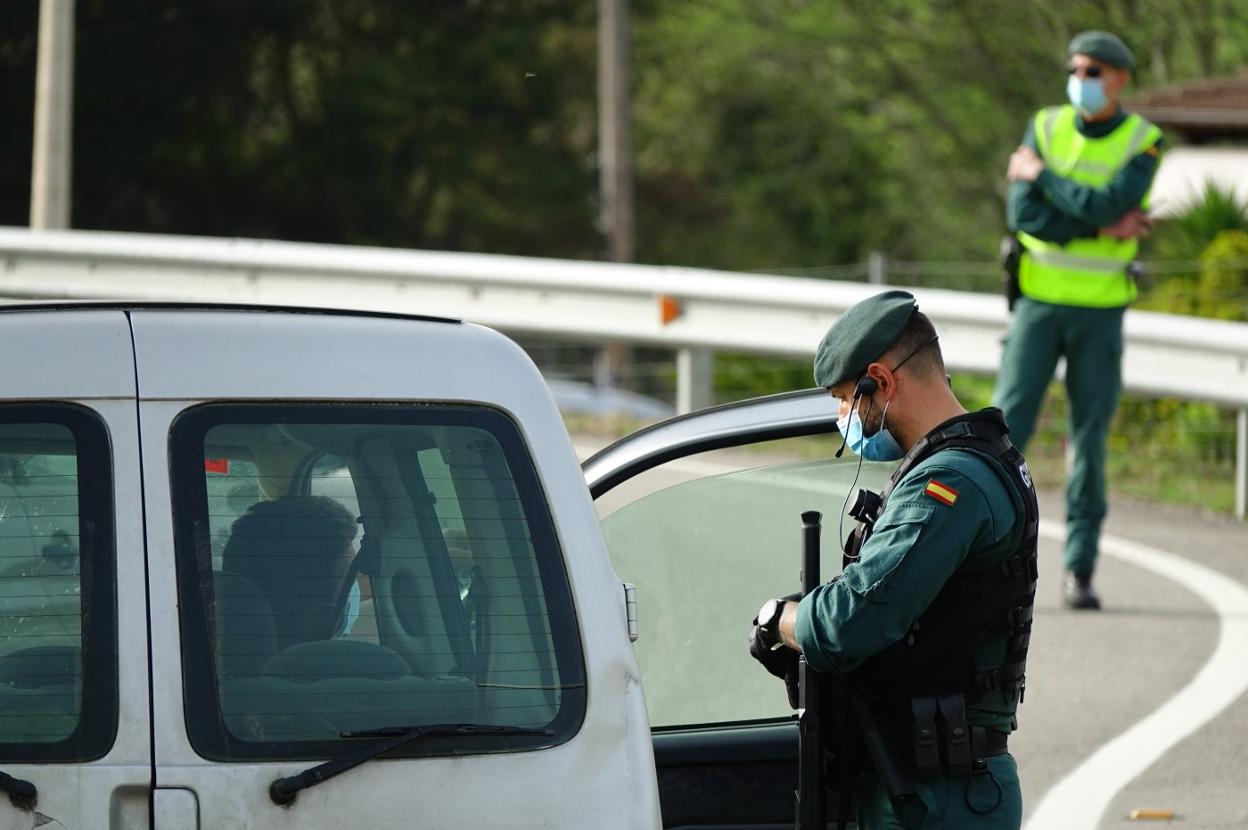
[578,439,1248,830]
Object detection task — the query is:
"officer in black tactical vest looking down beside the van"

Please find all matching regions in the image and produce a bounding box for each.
[750,290,1038,830]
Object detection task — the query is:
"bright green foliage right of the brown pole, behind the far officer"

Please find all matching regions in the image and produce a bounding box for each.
[635,0,1248,268]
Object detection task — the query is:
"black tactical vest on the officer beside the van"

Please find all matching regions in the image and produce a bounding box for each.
[849,408,1040,704]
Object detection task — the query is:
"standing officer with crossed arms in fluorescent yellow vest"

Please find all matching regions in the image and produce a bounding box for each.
[993,31,1162,609]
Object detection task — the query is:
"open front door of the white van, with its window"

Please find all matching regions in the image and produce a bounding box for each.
[583,389,894,830]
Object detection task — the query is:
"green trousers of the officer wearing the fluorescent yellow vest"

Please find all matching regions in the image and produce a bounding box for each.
[993,297,1126,575]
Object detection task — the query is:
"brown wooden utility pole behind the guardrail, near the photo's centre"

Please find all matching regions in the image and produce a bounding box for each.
[594,0,634,399]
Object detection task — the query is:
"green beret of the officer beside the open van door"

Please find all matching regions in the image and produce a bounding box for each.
[815,290,919,389]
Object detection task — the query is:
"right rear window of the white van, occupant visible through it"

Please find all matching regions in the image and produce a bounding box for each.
[171,404,585,760]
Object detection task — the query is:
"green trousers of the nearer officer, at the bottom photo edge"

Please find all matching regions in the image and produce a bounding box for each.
[857,754,1022,830]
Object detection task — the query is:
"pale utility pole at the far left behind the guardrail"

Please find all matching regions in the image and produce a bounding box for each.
[30,0,74,228]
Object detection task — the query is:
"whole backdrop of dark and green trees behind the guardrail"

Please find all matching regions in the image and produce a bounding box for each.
[0,0,1248,265]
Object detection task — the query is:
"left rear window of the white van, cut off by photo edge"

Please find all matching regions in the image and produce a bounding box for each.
[0,406,116,763]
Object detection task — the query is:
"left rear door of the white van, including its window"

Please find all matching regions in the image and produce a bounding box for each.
[0,307,152,830]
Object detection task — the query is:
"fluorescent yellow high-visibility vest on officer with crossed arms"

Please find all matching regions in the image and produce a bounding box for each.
[1018,104,1162,308]
